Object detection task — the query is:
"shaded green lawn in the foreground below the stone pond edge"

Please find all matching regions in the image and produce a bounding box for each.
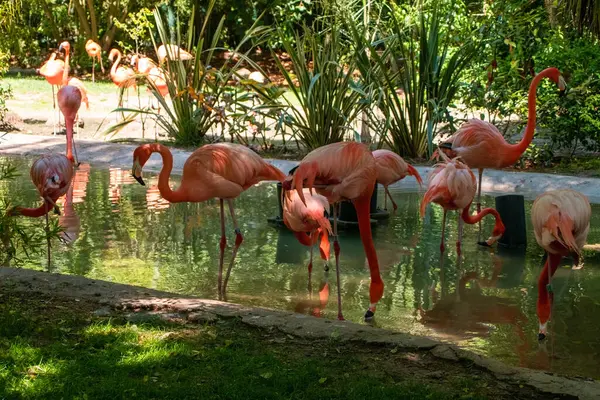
[0,288,542,399]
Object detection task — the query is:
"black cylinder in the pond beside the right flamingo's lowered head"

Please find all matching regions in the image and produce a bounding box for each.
[496,194,527,247]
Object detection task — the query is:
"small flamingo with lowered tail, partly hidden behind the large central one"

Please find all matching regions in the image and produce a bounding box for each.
[373,150,423,211]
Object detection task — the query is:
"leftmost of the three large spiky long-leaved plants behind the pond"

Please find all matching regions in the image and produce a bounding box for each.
[106,0,268,145]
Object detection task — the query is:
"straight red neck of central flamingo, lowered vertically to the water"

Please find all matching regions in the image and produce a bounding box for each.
[353,191,383,311]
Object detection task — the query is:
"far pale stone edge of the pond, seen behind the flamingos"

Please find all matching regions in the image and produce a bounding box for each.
[0,133,600,203]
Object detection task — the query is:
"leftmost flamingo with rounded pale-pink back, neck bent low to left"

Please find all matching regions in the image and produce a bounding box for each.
[9,154,73,268]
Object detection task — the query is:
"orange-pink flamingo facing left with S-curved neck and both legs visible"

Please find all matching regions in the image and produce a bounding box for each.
[132,143,285,299]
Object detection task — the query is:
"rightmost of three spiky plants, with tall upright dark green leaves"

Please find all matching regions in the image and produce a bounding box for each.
[354,4,477,157]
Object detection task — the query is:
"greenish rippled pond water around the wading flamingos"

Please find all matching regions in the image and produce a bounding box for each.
[0,158,600,379]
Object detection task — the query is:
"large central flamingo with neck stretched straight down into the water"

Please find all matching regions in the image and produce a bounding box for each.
[283,142,383,320]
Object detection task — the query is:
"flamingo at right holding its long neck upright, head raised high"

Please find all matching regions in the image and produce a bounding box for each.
[434,67,566,240]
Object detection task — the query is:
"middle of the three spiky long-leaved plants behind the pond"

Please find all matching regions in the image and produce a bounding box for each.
[264,25,369,150]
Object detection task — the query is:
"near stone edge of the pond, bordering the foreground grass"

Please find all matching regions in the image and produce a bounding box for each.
[0,267,600,399]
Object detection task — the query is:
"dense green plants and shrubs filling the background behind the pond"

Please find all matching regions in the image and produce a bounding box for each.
[0,0,600,159]
